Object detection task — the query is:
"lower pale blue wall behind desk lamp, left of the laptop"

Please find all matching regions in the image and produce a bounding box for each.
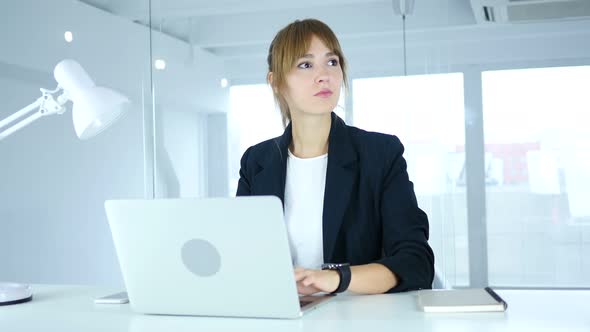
[0,79,143,284]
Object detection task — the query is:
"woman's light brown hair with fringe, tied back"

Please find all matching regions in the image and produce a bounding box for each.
[267,19,348,127]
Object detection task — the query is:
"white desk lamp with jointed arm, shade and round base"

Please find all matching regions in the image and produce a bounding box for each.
[0,59,130,306]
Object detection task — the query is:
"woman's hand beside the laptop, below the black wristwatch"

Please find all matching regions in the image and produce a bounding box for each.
[295,267,340,295]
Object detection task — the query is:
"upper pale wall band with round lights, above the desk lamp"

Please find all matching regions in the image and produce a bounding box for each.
[0,0,227,111]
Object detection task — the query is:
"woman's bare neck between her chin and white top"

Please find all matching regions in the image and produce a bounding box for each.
[289,113,332,158]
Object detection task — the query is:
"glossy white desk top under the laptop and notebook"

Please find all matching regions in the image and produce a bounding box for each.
[0,285,590,332]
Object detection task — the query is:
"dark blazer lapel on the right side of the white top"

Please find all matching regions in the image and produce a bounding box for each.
[323,113,358,262]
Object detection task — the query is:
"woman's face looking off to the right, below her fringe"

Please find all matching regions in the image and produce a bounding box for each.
[283,36,342,118]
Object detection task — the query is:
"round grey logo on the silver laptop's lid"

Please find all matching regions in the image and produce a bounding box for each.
[182,239,221,277]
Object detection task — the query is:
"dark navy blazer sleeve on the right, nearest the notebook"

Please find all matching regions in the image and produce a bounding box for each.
[377,136,434,293]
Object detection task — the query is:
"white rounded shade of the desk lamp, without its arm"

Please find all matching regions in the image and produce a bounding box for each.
[53,59,131,139]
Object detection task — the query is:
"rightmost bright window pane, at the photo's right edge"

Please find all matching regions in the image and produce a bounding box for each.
[482,66,590,287]
